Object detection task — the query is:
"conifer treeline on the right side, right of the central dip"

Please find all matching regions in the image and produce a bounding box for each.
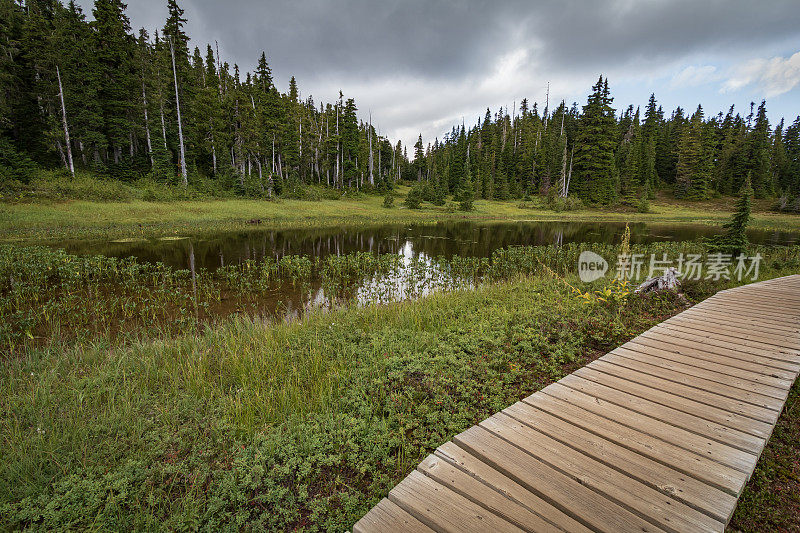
[418,77,800,210]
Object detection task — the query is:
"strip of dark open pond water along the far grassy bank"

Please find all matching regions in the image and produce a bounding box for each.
[55,218,800,271]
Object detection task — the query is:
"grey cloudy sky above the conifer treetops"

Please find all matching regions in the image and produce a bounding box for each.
[80,0,800,148]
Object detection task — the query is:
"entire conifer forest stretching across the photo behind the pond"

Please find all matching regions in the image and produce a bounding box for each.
[0,0,800,211]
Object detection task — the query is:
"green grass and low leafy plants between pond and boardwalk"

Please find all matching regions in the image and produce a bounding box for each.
[0,251,796,531]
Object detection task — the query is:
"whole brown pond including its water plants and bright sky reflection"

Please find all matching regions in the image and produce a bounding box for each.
[8,221,798,330]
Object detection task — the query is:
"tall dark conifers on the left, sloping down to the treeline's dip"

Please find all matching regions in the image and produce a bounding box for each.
[0,0,400,196]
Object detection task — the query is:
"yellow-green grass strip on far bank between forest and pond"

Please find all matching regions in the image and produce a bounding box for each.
[0,183,800,242]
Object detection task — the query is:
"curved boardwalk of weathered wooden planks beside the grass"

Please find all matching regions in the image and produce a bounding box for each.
[353,275,800,533]
